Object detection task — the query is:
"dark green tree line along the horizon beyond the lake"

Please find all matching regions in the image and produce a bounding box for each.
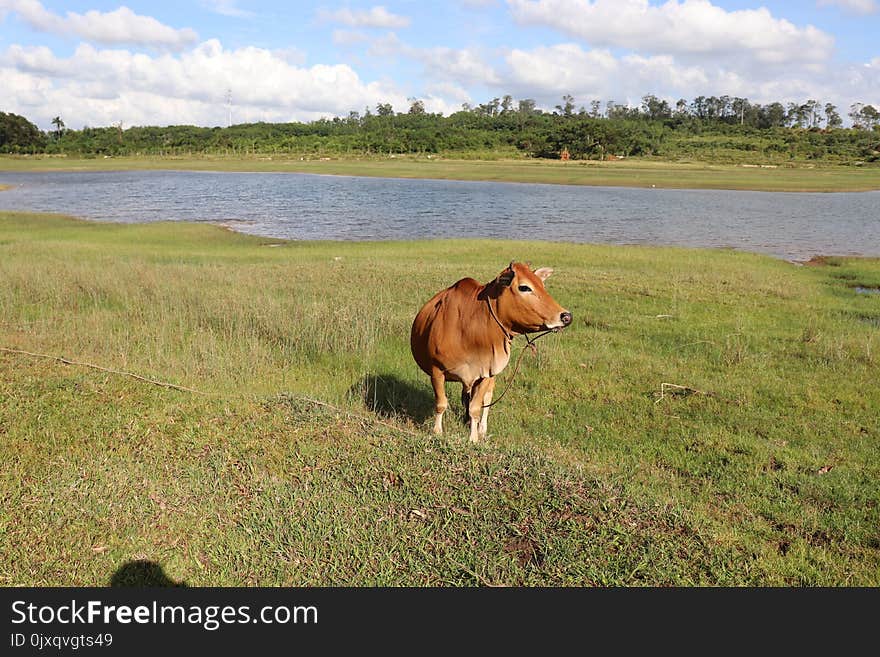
[0,94,880,162]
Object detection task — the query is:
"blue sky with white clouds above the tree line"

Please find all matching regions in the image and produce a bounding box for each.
[0,0,880,130]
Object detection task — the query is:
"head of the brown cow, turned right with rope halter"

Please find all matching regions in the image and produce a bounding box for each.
[491,262,571,333]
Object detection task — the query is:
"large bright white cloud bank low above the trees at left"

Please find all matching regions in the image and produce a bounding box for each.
[0,40,412,128]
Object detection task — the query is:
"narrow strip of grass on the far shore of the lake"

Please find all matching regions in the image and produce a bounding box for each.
[0,156,880,192]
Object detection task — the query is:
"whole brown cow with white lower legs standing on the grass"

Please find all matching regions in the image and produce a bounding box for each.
[410,262,571,442]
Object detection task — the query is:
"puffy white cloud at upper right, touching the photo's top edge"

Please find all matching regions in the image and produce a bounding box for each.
[508,0,834,64]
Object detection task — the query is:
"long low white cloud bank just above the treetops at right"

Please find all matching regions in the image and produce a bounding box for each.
[312,19,880,116]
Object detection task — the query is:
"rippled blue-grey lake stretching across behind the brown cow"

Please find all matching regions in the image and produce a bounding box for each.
[0,171,880,260]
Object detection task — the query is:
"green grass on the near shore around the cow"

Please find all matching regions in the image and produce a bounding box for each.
[0,213,880,586]
